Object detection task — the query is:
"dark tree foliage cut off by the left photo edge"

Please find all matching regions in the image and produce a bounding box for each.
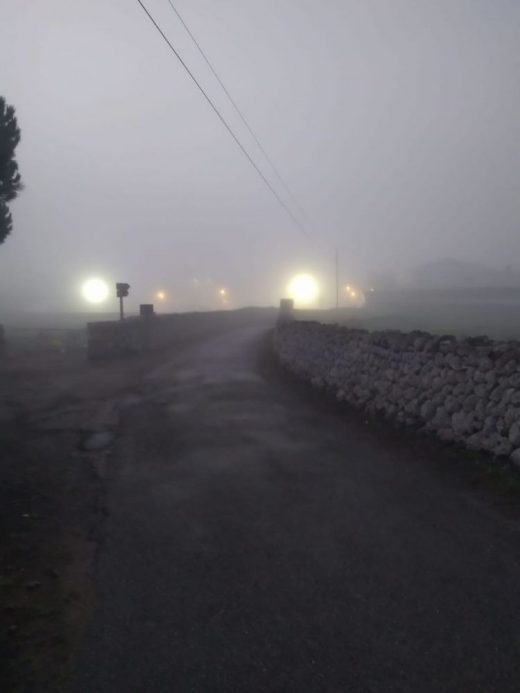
[0,96,22,243]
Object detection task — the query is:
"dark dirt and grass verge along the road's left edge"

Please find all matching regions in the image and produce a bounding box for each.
[0,353,181,693]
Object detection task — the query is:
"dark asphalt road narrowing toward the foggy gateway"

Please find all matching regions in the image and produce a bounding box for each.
[74,329,520,693]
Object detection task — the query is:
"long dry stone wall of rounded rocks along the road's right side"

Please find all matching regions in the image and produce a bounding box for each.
[274,321,520,464]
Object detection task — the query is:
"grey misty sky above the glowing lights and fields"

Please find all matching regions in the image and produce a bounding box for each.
[0,0,520,310]
